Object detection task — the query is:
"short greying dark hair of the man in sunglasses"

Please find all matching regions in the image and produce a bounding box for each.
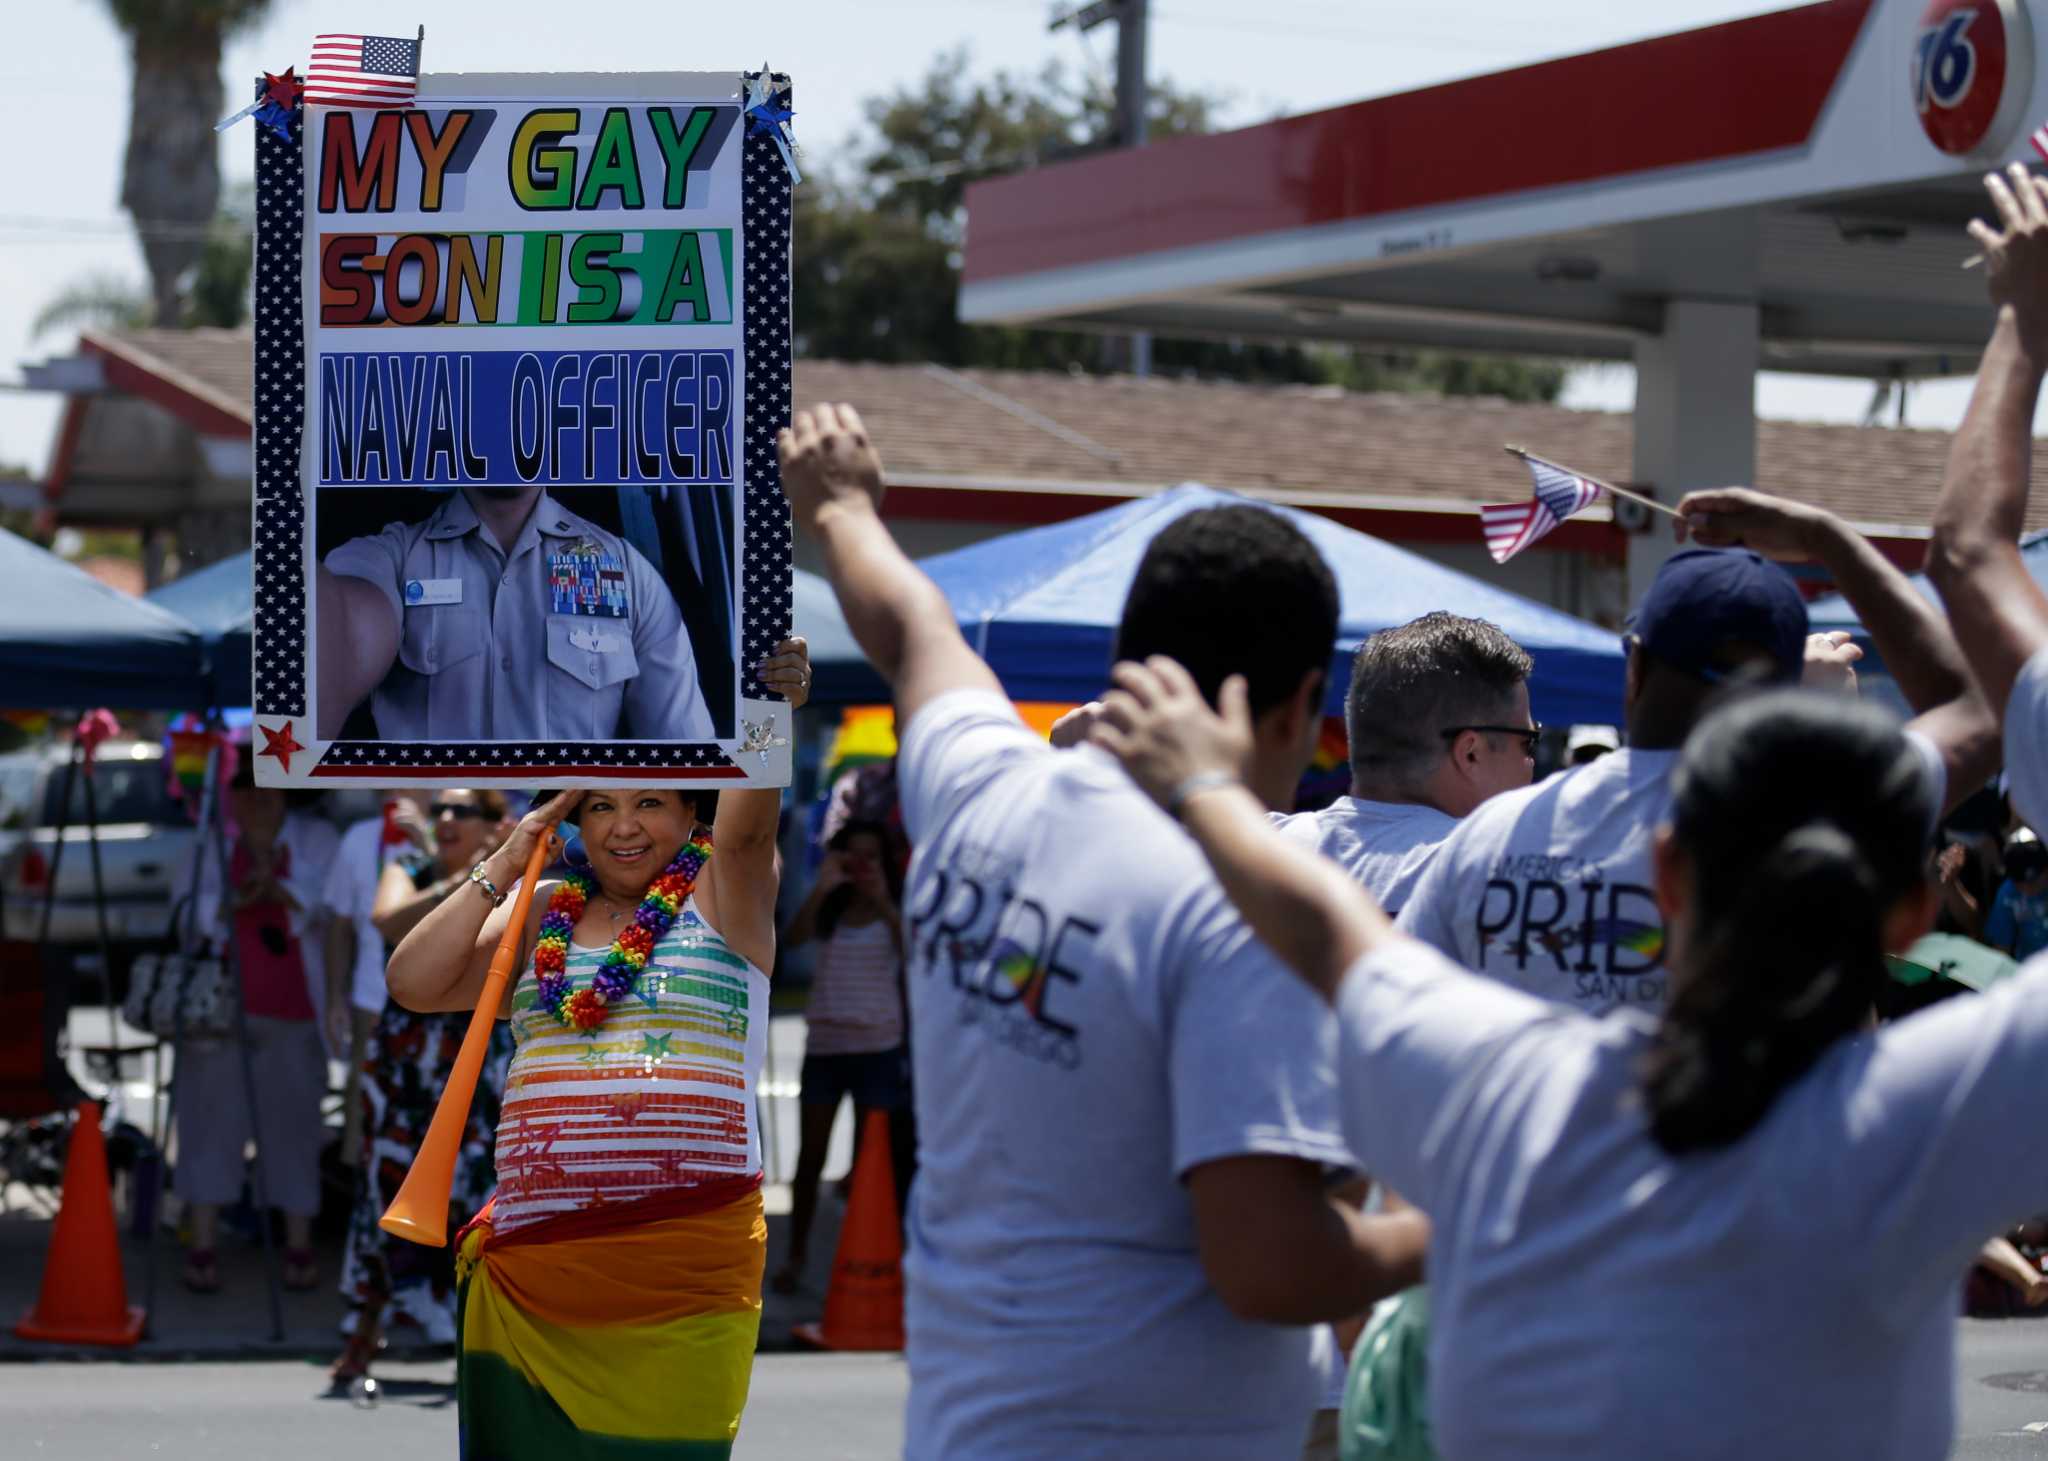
[1343,609,1536,785]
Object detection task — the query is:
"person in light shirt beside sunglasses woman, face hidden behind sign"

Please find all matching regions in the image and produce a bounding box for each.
[319,791,430,1166]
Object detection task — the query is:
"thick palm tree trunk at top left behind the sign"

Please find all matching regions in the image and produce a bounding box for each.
[106,0,270,326]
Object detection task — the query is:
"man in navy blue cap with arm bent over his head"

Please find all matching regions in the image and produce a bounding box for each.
[1399,512,1997,1014]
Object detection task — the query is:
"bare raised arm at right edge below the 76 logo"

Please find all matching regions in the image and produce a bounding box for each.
[1927,162,2048,719]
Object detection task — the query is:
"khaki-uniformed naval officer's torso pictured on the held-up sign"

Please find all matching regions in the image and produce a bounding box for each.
[315,486,713,742]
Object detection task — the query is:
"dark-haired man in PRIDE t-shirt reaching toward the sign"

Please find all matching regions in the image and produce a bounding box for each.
[780,406,1427,1461]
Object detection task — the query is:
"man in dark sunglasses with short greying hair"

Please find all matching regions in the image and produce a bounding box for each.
[1280,611,1540,914]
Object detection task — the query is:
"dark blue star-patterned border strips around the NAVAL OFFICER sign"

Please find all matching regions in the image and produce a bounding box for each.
[250,72,791,783]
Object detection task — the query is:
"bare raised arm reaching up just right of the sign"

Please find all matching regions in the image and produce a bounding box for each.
[778,406,1001,727]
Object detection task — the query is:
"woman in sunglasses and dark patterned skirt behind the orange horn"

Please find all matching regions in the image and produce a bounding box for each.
[334,789,512,1379]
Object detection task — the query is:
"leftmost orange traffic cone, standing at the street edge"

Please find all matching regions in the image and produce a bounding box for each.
[14,1100,141,1346]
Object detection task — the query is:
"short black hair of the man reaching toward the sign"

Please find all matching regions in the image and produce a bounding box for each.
[1116,506,1337,715]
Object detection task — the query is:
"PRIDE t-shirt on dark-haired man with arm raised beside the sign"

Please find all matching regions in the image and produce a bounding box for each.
[897,691,1350,1461]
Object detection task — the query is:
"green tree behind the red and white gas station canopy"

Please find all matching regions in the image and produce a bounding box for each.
[793,51,1565,402]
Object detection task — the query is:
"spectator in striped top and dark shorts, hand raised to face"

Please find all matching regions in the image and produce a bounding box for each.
[770,822,909,1293]
